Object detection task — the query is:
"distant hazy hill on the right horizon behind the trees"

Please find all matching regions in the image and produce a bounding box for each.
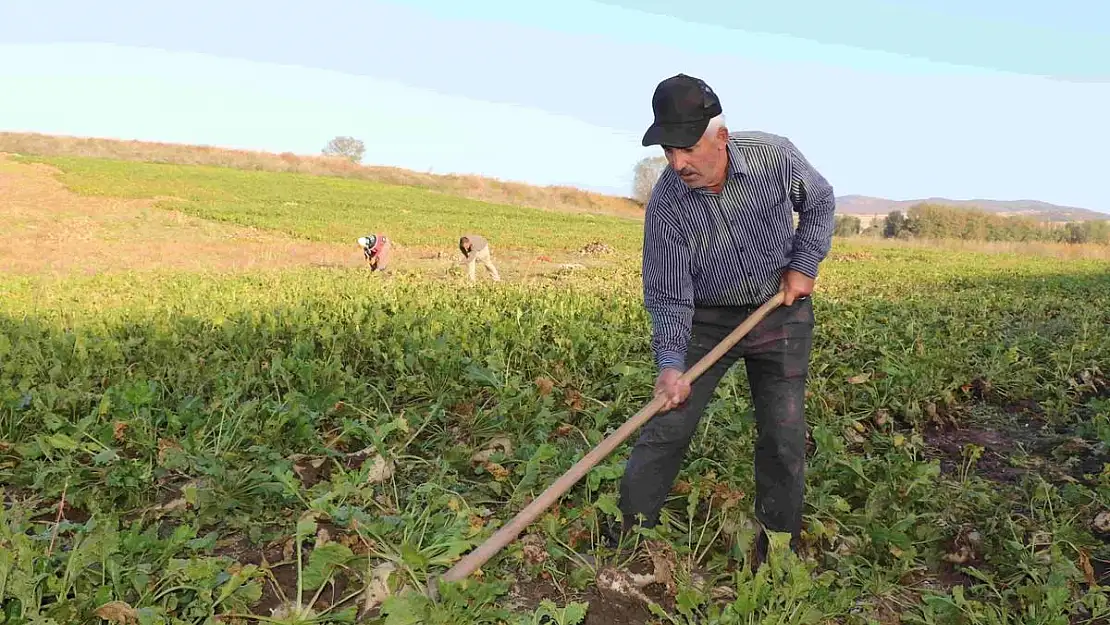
[837,195,1110,222]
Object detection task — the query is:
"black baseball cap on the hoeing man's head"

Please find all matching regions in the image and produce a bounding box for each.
[643,73,722,148]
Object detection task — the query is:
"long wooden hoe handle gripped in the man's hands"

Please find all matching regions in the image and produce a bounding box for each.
[441,292,784,582]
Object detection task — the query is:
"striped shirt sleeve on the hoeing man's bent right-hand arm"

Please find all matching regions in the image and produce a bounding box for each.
[787,144,836,278]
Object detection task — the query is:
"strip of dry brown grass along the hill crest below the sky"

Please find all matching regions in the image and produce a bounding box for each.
[0,132,643,218]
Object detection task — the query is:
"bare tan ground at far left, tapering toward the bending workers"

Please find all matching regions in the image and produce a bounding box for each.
[0,154,362,274]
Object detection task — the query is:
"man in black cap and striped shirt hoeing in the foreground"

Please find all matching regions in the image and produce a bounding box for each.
[609,74,835,566]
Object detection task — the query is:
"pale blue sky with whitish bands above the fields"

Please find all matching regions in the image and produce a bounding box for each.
[0,0,1110,212]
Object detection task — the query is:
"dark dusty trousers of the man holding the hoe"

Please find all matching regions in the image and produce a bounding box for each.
[619,298,815,544]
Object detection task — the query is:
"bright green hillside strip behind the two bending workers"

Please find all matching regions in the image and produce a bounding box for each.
[20,157,642,252]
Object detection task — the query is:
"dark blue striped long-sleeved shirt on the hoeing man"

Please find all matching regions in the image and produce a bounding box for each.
[643,131,836,371]
